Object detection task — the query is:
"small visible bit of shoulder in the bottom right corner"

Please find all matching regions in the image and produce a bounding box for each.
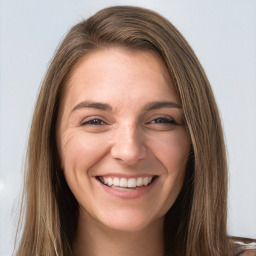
[231,237,256,256]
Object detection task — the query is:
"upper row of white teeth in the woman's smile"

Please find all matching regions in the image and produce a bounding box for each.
[99,176,153,188]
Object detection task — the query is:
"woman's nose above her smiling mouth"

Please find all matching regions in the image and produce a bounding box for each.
[111,125,147,165]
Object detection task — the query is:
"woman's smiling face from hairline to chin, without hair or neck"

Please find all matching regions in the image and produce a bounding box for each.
[58,47,190,231]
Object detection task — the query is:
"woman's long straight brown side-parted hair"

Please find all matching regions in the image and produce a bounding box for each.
[15,6,233,256]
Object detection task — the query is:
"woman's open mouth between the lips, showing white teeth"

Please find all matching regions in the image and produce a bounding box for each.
[96,176,157,191]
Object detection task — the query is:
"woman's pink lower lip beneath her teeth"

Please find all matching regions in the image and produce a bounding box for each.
[95,178,157,199]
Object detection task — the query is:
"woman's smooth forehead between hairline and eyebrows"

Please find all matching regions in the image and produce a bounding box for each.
[62,47,179,108]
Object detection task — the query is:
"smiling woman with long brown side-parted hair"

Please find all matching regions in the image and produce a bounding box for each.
[16,4,255,256]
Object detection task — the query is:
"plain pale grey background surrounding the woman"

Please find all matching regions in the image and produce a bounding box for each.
[0,0,256,256]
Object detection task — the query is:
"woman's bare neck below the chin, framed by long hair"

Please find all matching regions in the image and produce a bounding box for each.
[73,210,164,256]
